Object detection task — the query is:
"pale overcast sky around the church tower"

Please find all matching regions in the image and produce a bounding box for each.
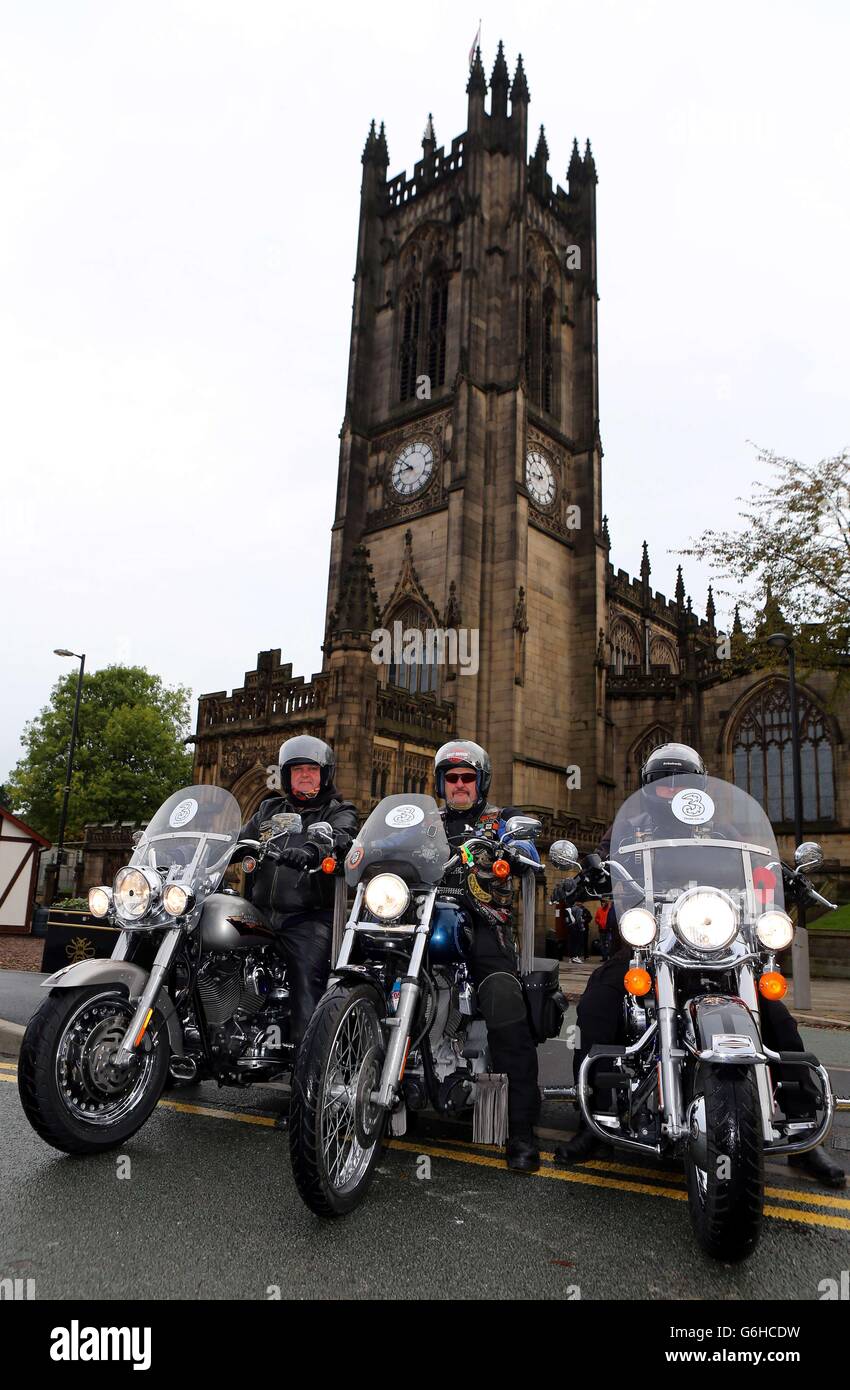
[0,0,850,780]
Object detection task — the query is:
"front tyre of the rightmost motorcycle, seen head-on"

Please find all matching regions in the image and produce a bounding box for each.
[685,1066,764,1262]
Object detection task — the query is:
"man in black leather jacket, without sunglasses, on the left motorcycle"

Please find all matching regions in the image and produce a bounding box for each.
[242,734,357,1044]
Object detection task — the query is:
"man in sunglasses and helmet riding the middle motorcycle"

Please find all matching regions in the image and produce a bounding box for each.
[433,739,540,1173]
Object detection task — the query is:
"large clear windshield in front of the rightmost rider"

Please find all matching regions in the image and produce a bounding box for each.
[610,776,785,917]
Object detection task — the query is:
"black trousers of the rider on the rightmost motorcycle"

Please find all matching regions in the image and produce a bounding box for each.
[572,947,811,1115]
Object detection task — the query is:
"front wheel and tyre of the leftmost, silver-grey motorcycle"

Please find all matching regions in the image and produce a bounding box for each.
[18,984,171,1154]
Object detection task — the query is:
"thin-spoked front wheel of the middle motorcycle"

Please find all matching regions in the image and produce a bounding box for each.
[289,984,386,1216]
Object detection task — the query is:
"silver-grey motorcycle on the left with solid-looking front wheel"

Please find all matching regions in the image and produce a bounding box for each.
[18,787,342,1154]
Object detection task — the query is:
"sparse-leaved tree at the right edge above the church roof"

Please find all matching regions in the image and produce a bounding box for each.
[678,449,850,666]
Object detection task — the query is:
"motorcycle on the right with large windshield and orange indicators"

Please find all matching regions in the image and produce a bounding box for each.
[549,778,850,1261]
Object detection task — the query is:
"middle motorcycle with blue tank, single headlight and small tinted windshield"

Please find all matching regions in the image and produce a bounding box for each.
[289,794,565,1218]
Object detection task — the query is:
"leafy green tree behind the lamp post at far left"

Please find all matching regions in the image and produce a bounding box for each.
[7,666,192,840]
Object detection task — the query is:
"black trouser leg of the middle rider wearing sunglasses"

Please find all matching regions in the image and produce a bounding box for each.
[467,922,540,1136]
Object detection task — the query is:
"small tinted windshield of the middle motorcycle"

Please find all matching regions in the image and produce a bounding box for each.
[346,792,451,887]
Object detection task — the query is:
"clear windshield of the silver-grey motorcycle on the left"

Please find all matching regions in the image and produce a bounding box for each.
[131,787,242,892]
